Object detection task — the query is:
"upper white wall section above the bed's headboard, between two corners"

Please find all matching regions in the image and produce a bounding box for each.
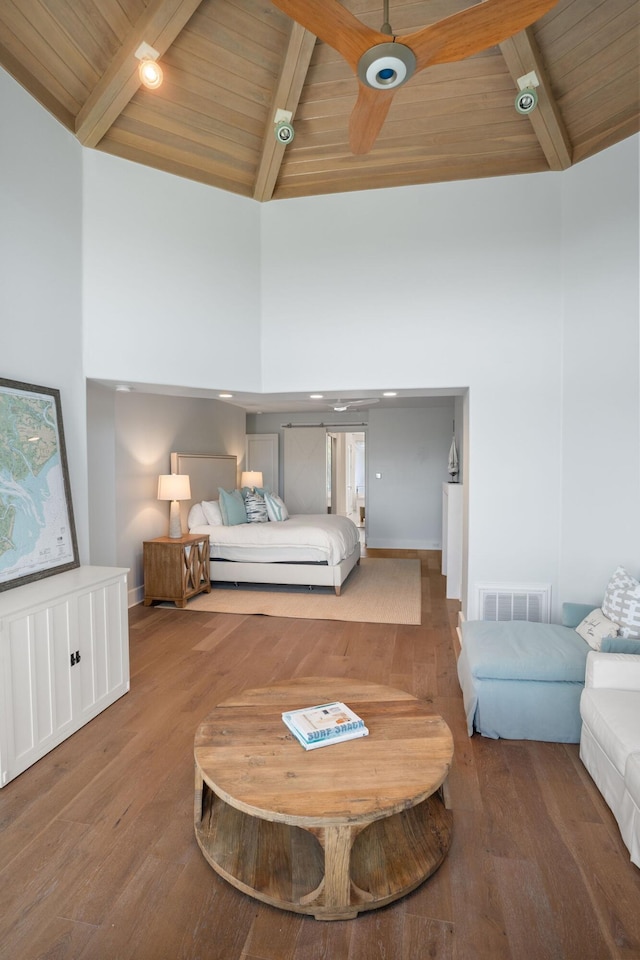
[83,150,261,390]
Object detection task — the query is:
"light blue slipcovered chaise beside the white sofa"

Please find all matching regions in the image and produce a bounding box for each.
[458,603,640,743]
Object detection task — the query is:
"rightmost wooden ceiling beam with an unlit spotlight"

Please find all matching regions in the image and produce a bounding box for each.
[500,27,573,170]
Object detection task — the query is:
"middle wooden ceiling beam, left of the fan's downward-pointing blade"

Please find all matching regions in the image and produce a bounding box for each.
[253,20,316,201]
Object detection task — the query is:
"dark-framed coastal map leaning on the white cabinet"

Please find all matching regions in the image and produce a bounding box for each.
[0,378,79,590]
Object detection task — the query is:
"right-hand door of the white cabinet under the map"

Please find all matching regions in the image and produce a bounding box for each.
[74,580,129,725]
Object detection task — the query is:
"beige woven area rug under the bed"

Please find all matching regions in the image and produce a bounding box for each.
[175,558,421,624]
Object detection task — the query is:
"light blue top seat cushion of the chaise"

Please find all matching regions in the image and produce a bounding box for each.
[462,620,590,683]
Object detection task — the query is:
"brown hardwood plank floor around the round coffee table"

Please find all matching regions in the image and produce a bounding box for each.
[0,551,640,960]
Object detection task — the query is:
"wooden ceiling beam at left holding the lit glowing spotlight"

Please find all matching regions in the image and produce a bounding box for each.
[75,0,201,147]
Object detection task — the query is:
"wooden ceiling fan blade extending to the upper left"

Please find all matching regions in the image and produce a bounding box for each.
[272,0,389,71]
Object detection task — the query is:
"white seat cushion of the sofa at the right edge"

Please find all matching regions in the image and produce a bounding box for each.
[580,687,640,777]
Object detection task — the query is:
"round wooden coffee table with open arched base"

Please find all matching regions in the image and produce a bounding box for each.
[194,678,453,920]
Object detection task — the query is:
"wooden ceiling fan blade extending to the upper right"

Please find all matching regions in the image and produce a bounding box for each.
[408,0,558,72]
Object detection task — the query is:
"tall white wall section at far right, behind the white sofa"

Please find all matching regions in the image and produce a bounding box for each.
[559,137,640,603]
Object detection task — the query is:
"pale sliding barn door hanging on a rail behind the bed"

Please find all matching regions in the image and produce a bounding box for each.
[284,427,327,513]
